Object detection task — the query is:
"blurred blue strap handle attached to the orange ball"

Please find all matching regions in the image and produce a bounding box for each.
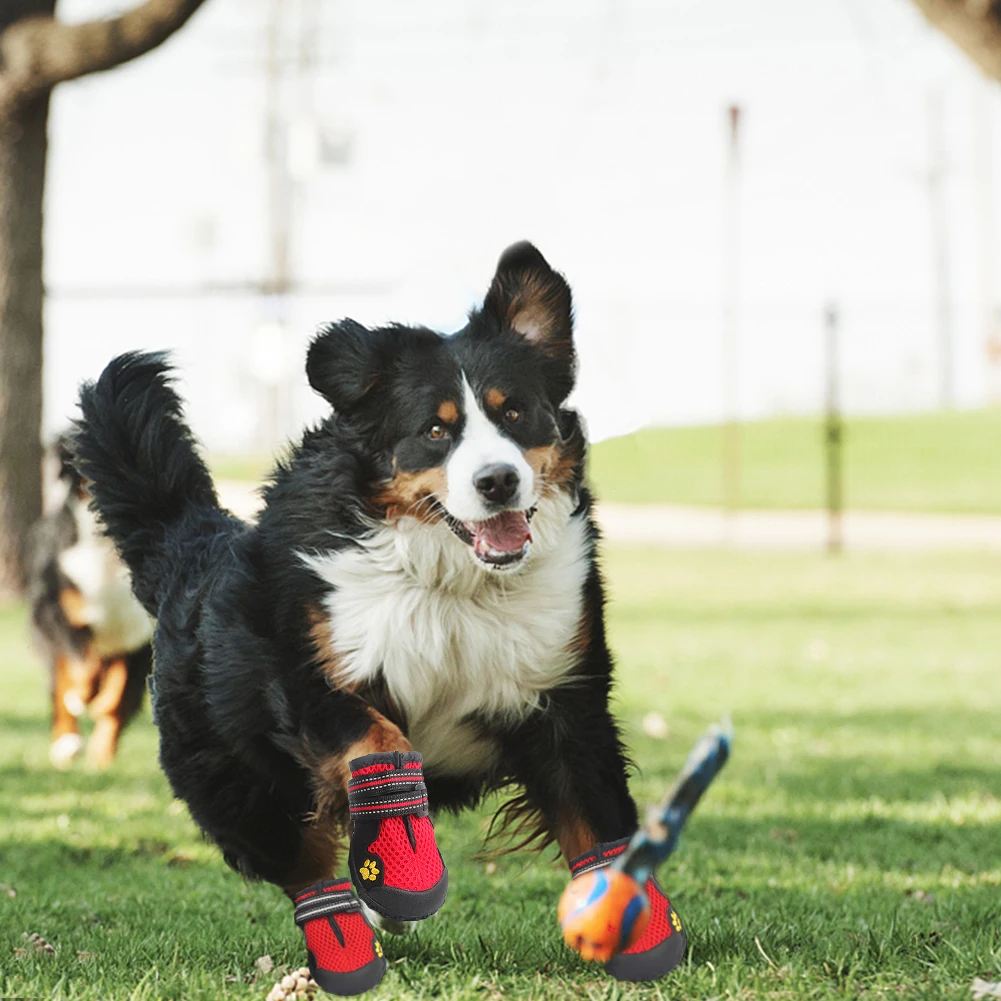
[612,720,734,886]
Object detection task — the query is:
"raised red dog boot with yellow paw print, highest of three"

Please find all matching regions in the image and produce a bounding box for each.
[347,751,448,921]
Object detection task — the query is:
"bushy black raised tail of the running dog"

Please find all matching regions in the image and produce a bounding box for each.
[73,351,219,616]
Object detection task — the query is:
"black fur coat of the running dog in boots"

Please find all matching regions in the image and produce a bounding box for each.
[74,244,637,891]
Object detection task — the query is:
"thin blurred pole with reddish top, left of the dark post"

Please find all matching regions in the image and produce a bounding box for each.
[721,104,741,515]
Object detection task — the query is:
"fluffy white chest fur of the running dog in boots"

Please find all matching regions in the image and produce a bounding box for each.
[305,498,588,774]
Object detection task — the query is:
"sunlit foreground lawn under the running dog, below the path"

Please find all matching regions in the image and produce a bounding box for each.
[0,551,1001,1001]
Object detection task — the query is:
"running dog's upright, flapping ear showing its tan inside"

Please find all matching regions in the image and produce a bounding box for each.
[483,241,576,401]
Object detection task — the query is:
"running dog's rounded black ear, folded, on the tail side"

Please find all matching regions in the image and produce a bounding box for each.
[306,319,379,410]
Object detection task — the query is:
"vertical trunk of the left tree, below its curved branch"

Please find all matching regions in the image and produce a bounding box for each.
[0,95,49,598]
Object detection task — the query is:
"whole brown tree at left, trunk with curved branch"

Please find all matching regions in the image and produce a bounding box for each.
[0,0,204,601]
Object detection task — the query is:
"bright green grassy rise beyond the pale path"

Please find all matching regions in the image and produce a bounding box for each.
[591,409,1001,514]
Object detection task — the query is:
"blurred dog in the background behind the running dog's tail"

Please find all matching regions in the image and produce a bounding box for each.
[28,439,153,768]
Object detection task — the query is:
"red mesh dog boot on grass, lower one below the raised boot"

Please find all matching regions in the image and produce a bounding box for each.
[295,876,385,995]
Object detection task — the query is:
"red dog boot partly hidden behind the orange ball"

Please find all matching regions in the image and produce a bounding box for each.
[570,838,688,981]
